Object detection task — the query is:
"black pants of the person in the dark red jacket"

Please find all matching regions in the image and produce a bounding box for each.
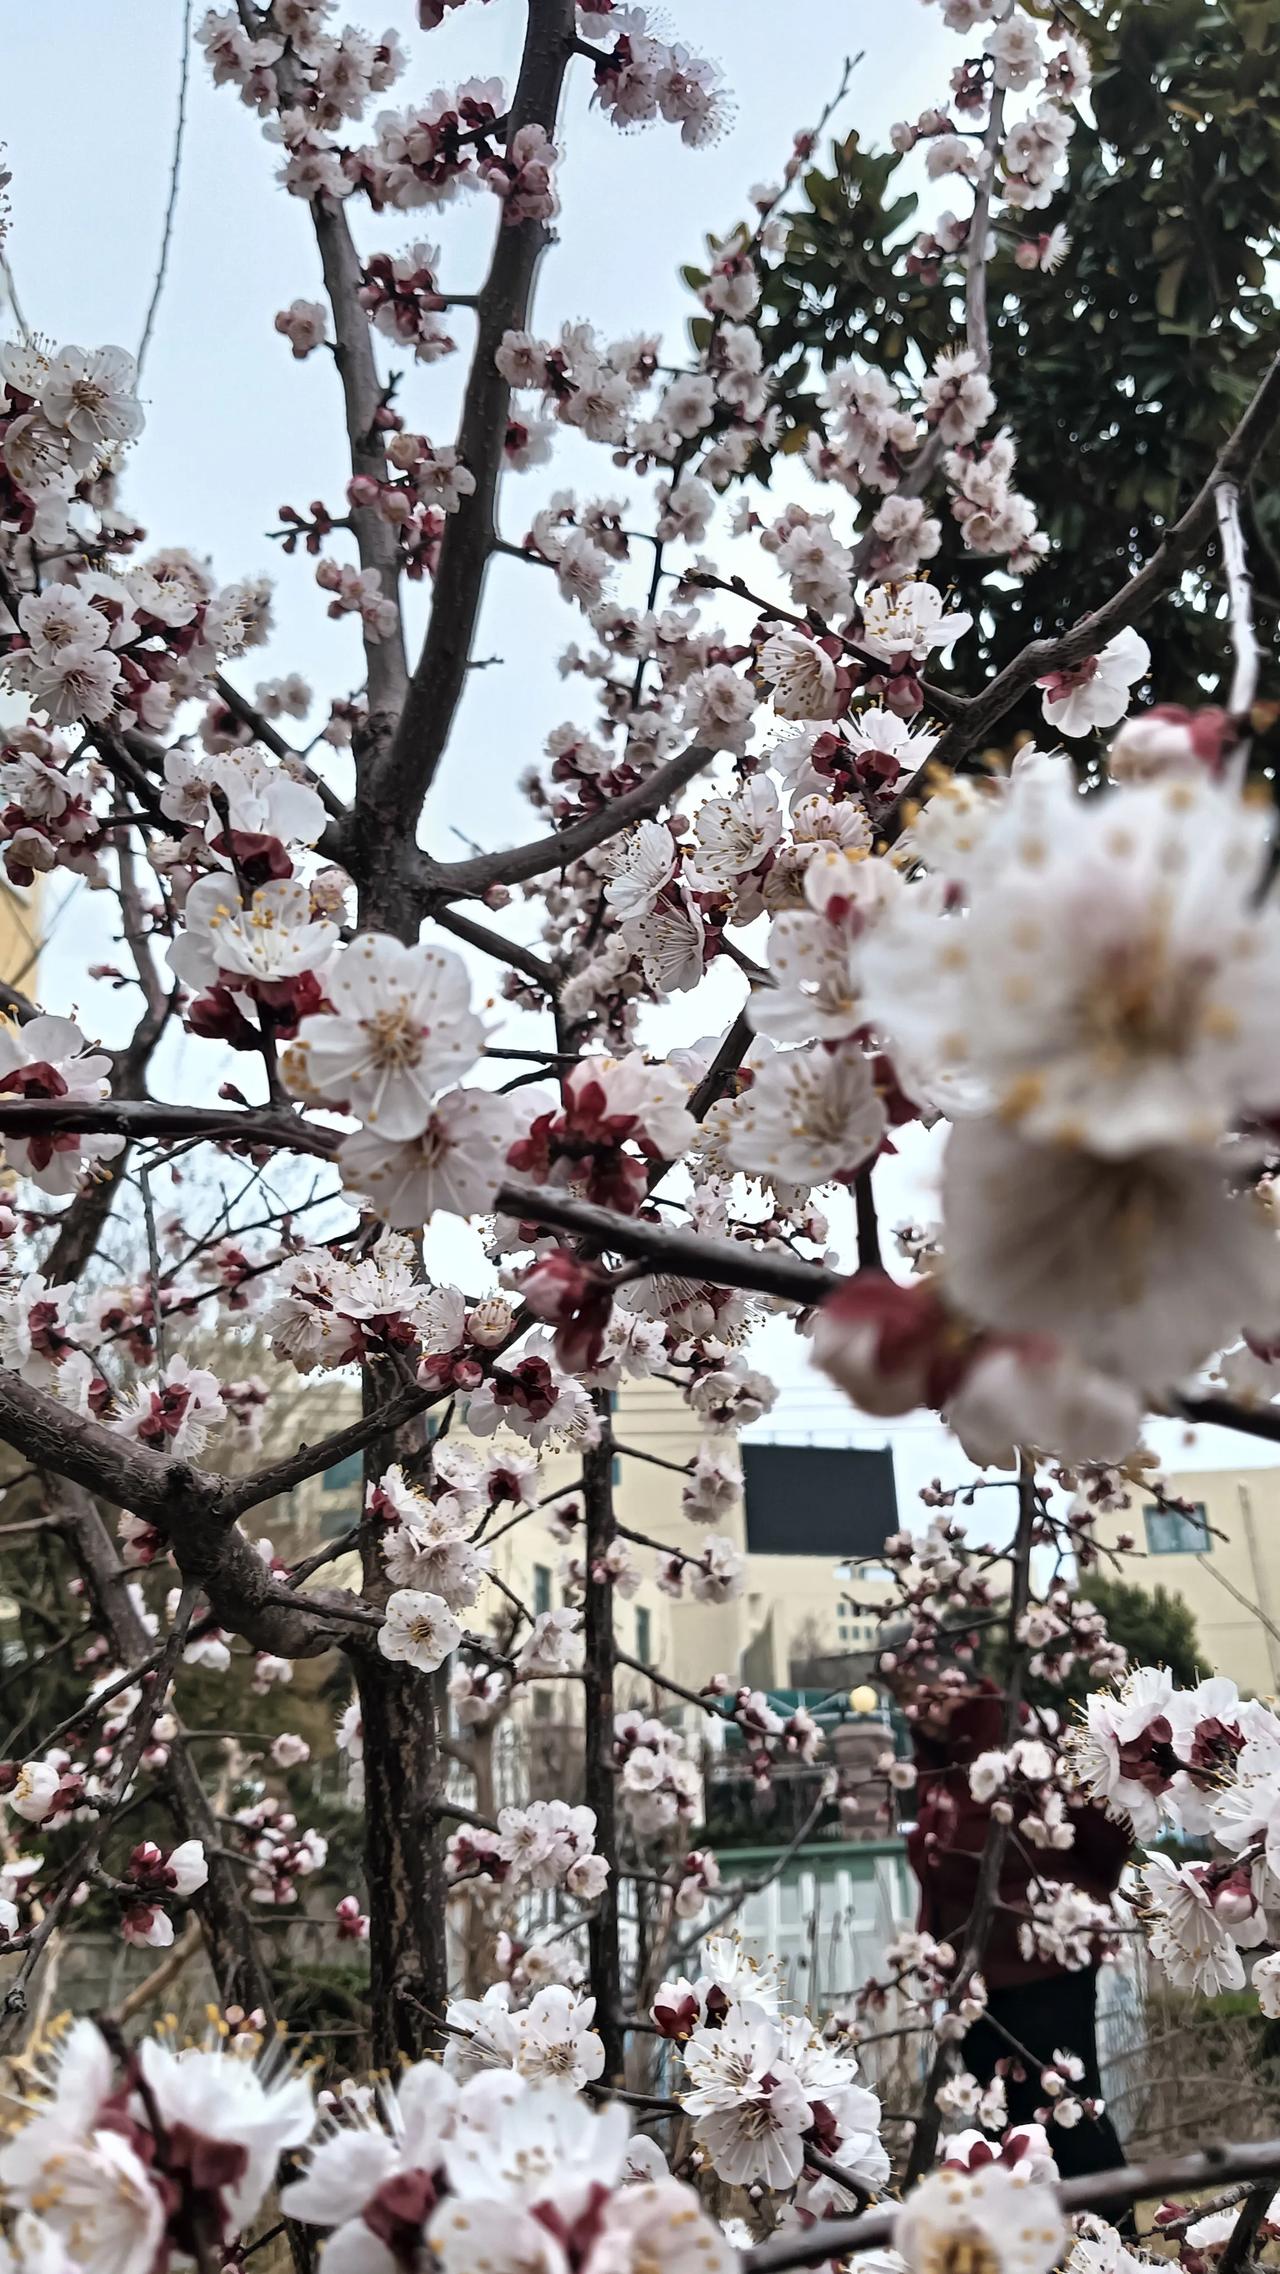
[959,1969,1125,2224]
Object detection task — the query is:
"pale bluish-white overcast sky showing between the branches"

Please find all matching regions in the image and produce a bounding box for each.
[0,0,1269,1517]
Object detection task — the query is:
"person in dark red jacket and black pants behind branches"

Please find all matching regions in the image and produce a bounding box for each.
[884,1667,1130,2178]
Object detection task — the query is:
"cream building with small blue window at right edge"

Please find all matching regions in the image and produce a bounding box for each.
[1096,1467,1280,1696]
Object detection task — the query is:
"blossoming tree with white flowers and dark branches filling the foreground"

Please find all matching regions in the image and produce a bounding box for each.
[0,0,1280,2274]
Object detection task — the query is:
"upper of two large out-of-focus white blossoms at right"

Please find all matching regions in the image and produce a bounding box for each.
[862,775,1280,1155]
